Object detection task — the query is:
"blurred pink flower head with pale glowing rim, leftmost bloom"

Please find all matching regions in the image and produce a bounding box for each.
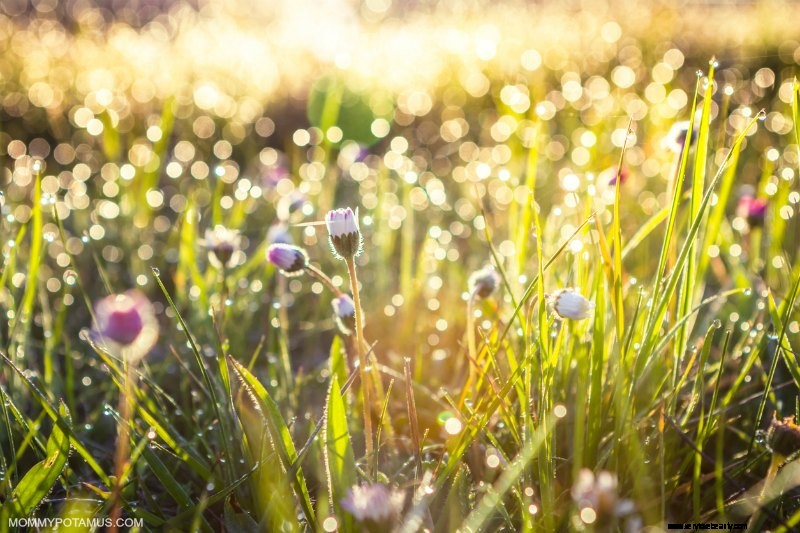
[94,290,158,362]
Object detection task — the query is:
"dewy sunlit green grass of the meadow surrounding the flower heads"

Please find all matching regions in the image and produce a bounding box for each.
[0,2,800,532]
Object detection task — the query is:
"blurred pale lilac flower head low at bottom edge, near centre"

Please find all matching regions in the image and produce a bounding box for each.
[341,483,405,531]
